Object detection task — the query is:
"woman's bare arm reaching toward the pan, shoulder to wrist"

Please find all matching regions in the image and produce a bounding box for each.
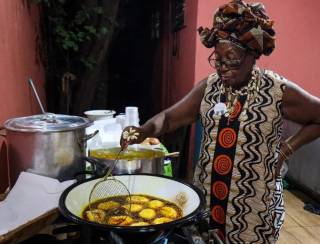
[120,79,207,145]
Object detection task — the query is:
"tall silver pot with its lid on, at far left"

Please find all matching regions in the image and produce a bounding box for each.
[4,113,96,183]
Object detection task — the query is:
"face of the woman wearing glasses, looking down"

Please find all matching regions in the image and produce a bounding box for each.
[213,42,255,89]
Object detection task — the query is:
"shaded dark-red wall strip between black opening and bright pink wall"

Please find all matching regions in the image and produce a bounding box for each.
[163,0,202,172]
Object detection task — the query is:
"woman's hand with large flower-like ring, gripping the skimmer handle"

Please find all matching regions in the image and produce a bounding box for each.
[120,126,147,148]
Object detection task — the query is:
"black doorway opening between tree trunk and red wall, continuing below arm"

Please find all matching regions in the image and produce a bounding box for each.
[107,0,190,178]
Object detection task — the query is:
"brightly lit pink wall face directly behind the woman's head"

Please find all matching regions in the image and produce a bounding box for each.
[194,0,320,96]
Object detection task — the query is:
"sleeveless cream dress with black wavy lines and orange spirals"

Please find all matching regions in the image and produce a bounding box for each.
[194,67,286,243]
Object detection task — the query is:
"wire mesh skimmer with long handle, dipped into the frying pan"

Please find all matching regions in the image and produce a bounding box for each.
[89,147,131,217]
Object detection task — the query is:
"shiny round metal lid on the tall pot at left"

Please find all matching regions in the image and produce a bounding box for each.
[4,113,92,132]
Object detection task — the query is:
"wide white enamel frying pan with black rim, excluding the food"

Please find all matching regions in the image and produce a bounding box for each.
[59,174,207,244]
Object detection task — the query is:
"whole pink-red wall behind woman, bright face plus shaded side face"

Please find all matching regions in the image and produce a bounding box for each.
[164,0,320,170]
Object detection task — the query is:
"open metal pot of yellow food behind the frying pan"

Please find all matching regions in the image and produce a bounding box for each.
[86,145,179,175]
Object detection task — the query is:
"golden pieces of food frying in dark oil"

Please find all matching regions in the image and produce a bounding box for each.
[82,195,182,226]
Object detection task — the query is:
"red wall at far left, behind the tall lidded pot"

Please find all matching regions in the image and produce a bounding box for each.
[0,0,45,193]
